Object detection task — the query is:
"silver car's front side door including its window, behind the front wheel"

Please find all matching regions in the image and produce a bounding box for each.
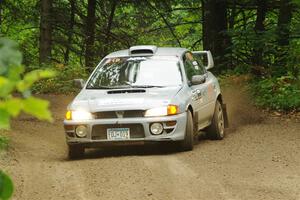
[183,52,208,125]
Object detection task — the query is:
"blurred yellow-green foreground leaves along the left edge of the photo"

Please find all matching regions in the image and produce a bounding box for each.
[0,38,54,200]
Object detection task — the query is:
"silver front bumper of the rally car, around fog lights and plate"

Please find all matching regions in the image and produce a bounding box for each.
[64,113,186,147]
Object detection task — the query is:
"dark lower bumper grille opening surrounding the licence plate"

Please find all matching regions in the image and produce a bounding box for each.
[92,124,145,140]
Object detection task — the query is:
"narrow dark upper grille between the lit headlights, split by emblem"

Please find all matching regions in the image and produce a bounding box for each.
[94,110,145,119]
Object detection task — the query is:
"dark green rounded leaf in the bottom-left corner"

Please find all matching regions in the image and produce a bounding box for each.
[0,170,14,200]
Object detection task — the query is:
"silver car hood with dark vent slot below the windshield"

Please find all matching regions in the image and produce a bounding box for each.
[68,86,181,112]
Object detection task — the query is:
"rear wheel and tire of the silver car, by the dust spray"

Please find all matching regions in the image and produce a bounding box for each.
[206,100,225,140]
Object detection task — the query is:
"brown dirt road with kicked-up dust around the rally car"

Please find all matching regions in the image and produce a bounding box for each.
[0,83,300,200]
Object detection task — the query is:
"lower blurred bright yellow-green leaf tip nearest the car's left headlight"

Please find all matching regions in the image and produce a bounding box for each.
[23,97,52,121]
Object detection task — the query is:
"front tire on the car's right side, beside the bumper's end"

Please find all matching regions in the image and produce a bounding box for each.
[180,111,194,151]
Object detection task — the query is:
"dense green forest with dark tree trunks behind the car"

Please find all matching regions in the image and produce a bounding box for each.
[0,0,300,109]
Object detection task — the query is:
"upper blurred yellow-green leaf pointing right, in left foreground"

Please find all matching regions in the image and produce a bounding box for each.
[17,70,55,92]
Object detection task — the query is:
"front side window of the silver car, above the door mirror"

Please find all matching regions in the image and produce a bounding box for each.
[183,52,205,81]
